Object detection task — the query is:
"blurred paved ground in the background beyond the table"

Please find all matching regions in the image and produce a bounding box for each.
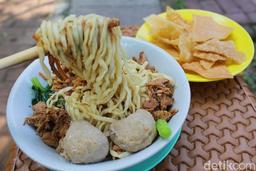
[0,0,256,171]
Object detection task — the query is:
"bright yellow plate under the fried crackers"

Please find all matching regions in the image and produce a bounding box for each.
[136,9,254,82]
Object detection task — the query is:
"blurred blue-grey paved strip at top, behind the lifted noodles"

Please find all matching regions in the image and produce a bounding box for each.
[70,0,161,25]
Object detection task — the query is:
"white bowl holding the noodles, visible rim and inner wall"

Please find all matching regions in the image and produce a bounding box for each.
[7,37,190,171]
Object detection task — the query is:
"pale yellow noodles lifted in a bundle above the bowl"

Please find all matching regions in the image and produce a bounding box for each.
[34,14,171,131]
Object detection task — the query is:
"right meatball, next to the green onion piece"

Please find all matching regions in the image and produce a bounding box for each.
[110,109,156,152]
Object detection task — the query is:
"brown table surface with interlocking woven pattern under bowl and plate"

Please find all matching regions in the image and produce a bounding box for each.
[6,26,256,171]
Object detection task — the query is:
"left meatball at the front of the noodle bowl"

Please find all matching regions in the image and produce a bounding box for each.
[60,121,109,163]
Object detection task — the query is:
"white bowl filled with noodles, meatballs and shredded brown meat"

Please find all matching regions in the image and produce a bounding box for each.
[7,15,190,171]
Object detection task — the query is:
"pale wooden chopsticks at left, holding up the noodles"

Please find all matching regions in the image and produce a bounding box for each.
[0,46,38,69]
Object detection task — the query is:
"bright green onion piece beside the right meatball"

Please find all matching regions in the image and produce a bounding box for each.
[156,119,172,139]
